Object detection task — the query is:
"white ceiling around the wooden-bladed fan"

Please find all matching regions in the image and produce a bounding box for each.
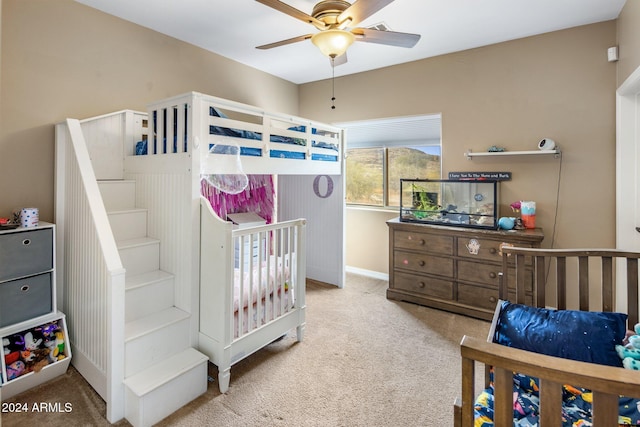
[76,0,626,84]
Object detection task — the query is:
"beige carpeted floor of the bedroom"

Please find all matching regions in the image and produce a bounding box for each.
[0,274,489,427]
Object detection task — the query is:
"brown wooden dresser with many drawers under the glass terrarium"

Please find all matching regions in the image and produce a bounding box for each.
[387,218,544,320]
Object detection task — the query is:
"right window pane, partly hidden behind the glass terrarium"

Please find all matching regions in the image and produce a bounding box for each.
[384,146,441,206]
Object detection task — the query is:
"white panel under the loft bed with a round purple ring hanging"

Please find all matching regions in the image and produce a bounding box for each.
[277,175,345,288]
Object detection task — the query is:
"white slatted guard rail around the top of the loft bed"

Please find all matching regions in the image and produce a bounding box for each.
[146,92,343,174]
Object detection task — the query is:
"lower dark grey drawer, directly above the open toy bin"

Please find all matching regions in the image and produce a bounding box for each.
[0,273,53,328]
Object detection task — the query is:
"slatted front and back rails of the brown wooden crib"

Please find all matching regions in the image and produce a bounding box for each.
[454,246,640,427]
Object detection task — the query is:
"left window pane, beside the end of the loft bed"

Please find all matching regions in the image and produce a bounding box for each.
[346,148,384,206]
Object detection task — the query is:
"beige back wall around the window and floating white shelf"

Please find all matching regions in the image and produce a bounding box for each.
[300,21,616,272]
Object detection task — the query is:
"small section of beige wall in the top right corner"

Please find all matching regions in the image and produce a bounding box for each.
[618,0,640,86]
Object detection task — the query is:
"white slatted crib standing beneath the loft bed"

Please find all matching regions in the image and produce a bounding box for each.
[199,197,306,393]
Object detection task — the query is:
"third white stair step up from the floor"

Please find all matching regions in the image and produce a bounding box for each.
[125,270,174,322]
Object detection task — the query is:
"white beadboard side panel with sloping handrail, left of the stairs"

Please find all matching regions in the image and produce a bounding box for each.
[55,119,125,422]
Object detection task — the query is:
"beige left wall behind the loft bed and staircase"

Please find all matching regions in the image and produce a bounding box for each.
[0,0,298,221]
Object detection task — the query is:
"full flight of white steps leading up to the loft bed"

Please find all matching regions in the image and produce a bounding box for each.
[98,180,208,427]
